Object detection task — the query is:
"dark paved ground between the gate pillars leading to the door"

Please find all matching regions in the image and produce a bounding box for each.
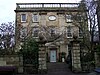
[18,63,87,75]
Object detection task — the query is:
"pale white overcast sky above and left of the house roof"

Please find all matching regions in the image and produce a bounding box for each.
[0,0,81,24]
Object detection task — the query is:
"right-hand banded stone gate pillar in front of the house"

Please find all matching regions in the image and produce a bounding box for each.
[71,40,82,72]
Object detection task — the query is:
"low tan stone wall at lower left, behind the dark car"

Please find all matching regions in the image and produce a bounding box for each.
[0,55,23,73]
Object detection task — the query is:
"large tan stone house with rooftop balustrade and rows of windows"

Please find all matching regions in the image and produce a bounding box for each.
[15,3,88,72]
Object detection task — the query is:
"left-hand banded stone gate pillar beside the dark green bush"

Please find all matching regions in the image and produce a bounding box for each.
[38,42,47,73]
